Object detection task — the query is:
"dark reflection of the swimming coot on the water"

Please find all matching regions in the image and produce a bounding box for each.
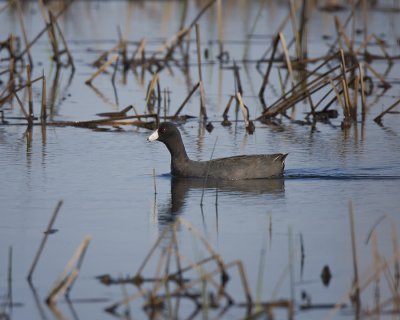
[159,177,285,224]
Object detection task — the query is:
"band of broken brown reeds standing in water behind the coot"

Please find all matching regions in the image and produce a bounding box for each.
[0,0,400,133]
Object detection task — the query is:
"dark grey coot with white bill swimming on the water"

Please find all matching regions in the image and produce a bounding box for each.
[147,122,287,180]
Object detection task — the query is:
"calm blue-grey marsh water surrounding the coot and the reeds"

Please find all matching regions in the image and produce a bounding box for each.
[0,1,400,319]
